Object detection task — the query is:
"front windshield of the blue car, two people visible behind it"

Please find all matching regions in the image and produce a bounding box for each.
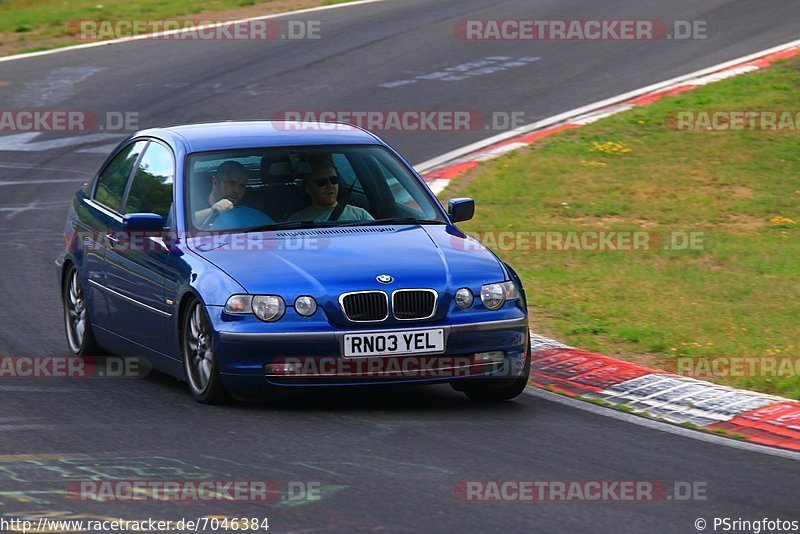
[186,145,446,231]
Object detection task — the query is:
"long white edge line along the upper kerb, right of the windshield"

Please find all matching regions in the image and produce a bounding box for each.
[414,39,800,174]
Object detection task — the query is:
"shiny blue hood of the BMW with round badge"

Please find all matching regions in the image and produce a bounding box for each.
[187,225,506,322]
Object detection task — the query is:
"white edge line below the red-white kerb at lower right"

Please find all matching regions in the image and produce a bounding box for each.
[525,386,800,461]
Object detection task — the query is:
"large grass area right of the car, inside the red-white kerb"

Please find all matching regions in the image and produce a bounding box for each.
[443,60,800,399]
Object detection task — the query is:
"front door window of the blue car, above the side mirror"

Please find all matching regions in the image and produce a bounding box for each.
[125,141,175,219]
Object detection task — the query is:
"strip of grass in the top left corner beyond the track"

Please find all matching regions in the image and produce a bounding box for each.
[0,0,353,55]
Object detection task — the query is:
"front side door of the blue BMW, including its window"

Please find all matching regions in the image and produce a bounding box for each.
[105,140,175,353]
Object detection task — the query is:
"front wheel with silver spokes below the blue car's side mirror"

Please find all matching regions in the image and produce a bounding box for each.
[181,299,229,404]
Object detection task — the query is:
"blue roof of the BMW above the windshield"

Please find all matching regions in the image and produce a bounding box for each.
[134,121,382,152]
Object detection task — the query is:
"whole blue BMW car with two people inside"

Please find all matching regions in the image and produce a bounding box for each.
[56,121,530,403]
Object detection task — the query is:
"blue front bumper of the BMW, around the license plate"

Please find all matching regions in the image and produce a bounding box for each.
[211,313,528,390]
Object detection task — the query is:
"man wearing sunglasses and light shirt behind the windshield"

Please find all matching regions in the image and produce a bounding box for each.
[289,159,374,222]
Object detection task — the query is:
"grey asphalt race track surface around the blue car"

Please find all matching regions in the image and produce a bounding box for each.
[0,0,800,532]
